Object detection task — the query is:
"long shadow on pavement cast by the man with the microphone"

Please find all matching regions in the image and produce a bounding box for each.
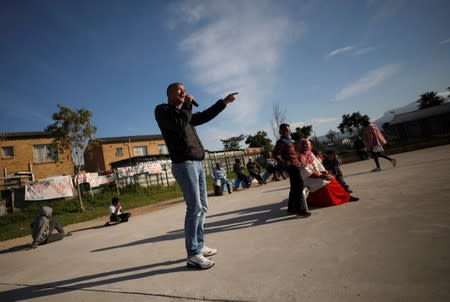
[0,259,194,301]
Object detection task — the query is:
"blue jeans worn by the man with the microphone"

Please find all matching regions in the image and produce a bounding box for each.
[172,160,208,257]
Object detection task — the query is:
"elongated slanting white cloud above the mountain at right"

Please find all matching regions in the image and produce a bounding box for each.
[335,64,399,101]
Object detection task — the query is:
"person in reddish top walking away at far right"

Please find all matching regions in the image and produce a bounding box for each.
[362,120,397,172]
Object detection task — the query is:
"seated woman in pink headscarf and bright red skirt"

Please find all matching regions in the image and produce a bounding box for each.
[298,139,359,207]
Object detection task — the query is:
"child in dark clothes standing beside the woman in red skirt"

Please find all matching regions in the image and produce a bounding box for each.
[273,124,311,217]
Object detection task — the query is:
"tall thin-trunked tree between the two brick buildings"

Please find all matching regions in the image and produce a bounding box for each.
[45,104,97,212]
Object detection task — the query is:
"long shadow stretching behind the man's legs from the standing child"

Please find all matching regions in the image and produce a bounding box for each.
[91,200,298,252]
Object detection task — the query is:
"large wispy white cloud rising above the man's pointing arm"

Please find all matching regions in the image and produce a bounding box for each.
[168,0,303,149]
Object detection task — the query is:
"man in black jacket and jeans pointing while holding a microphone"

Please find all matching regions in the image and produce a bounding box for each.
[155,82,237,269]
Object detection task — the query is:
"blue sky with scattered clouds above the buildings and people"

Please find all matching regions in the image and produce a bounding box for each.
[0,0,450,150]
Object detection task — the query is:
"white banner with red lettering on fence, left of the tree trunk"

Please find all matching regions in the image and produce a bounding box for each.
[25,175,74,200]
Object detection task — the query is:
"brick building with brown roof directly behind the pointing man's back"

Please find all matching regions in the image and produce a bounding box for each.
[84,135,168,172]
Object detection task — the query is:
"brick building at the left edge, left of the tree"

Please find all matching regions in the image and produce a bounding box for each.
[0,131,74,185]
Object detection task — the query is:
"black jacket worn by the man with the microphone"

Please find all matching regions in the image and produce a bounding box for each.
[155,100,226,163]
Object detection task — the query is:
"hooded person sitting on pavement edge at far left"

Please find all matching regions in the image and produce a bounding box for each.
[31,206,68,249]
